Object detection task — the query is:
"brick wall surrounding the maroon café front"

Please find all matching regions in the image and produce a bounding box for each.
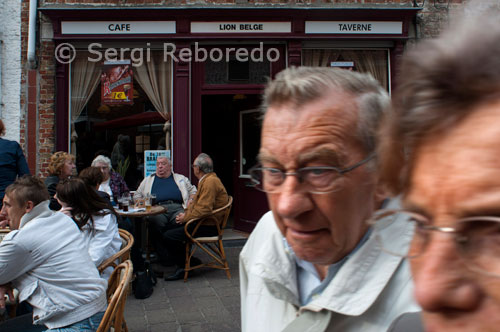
[19,0,466,176]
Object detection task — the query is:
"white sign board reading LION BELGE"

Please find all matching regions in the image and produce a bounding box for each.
[191,22,292,33]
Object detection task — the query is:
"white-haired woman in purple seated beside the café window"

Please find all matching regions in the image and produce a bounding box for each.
[92,155,130,205]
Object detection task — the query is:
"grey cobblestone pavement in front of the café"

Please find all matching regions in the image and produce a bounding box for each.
[124,247,242,332]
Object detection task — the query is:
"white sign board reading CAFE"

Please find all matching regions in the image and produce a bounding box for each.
[61,21,175,35]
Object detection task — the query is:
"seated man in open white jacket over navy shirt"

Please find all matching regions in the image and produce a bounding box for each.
[135,157,196,262]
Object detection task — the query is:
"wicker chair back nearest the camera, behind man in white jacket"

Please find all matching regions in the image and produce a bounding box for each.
[97,260,133,332]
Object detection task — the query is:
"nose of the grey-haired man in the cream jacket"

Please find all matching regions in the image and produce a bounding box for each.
[270,176,313,218]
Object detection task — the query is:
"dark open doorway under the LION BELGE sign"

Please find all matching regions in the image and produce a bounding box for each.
[201,94,268,232]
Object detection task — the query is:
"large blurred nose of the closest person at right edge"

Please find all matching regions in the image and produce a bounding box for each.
[410,233,482,312]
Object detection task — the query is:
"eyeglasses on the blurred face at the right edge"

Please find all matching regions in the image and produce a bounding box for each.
[368,210,500,277]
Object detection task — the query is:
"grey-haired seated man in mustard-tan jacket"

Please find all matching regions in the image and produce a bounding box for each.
[163,153,229,281]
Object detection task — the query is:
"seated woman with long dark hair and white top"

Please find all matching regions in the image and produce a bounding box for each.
[56,178,122,280]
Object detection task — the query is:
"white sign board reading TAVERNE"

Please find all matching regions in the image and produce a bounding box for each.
[306,21,403,35]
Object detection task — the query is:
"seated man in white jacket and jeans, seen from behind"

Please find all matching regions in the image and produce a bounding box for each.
[0,176,107,331]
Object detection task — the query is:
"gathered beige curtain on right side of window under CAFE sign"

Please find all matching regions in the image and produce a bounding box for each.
[135,52,172,150]
